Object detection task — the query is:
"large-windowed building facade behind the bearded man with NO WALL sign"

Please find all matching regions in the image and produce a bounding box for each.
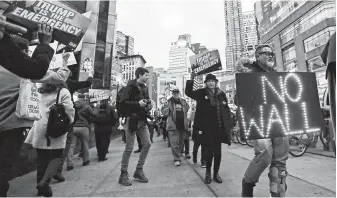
[255,0,336,102]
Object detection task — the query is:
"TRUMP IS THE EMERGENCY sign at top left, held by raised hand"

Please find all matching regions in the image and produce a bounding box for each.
[4,0,91,49]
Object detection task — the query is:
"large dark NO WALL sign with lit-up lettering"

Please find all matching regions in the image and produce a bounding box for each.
[236,72,324,140]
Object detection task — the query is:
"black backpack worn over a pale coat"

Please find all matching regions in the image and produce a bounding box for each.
[46,89,70,146]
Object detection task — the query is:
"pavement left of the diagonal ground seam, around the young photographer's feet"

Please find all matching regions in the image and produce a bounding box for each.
[8,137,214,197]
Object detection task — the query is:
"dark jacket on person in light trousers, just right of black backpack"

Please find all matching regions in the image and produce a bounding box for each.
[74,99,96,128]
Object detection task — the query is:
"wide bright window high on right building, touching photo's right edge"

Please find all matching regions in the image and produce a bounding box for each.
[304,27,336,52]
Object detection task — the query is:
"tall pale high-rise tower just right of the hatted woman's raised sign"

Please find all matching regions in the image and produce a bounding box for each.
[224,0,244,71]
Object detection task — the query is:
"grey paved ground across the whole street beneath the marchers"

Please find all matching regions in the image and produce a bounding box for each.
[9,135,336,197]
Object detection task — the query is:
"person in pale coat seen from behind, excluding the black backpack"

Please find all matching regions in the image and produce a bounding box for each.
[25,83,75,197]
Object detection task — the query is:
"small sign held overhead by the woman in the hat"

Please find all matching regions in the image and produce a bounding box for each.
[190,50,222,75]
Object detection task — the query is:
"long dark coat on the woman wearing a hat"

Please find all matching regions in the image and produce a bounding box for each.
[185,80,232,145]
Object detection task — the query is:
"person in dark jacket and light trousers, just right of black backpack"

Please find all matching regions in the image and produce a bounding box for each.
[67,94,97,171]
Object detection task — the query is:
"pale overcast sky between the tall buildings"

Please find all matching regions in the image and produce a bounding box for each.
[117,0,254,68]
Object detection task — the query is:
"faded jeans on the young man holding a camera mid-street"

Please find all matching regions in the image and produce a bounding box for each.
[121,118,151,172]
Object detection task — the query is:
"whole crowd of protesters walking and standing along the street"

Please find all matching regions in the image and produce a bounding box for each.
[0,15,289,197]
